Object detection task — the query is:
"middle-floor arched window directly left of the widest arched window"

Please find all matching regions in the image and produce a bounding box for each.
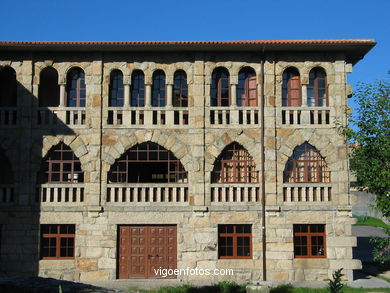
[38,142,84,184]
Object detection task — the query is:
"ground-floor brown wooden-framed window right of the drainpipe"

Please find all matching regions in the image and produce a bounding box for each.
[294,224,326,258]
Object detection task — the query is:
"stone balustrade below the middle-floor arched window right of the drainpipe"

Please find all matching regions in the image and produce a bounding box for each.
[283,183,332,202]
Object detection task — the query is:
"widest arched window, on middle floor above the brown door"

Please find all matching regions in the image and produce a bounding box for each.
[108,142,187,183]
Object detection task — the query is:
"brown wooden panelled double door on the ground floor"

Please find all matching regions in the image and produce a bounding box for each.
[118,225,177,279]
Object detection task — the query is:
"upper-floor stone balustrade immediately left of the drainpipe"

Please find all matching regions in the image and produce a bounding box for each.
[210,107,260,125]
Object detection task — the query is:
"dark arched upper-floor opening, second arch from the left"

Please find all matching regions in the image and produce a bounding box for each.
[38,67,60,107]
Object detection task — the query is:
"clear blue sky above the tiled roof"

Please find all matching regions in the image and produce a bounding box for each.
[0,0,390,109]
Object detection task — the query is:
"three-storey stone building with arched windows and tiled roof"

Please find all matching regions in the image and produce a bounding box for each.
[0,39,375,282]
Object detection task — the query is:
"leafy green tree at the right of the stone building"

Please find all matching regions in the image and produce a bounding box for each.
[344,71,390,264]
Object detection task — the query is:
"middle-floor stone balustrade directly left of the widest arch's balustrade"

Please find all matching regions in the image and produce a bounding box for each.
[35,183,85,205]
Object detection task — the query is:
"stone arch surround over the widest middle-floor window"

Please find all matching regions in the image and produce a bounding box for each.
[102,130,193,171]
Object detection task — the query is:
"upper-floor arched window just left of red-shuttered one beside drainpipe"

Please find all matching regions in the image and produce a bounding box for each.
[210,67,230,107]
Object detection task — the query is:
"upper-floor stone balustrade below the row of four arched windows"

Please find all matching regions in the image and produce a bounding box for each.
[107,107,189,127]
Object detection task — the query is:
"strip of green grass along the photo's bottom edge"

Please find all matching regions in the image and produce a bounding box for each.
[131,282,390,293]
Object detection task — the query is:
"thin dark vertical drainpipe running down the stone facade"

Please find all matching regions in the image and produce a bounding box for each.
[260,55,267,281]
